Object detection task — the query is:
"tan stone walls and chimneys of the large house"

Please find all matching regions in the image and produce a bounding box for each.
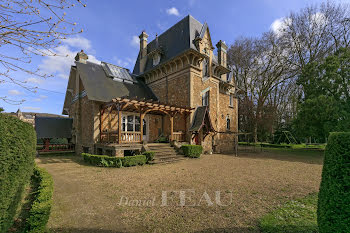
[67,15,238,155]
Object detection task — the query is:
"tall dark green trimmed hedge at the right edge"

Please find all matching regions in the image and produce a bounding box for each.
[317,132,350,233]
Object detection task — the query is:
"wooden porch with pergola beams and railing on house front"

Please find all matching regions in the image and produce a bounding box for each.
[99,98,193,145]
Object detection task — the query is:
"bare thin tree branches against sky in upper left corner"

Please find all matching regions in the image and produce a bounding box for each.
[0,0,85,104]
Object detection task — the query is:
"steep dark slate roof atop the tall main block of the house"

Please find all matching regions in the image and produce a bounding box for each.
[133,15,208,75]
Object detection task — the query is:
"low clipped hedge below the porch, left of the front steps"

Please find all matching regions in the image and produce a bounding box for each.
[82,153,147,168]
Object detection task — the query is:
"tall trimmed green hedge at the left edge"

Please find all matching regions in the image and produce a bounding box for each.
[0,114,36,232]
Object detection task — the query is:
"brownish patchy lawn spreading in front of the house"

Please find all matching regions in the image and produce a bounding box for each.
[37,150,323,232]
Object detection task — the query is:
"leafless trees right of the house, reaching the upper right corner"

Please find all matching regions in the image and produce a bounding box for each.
[228,2,350,141]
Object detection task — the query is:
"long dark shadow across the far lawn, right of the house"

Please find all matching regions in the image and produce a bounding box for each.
[238,149,324,165]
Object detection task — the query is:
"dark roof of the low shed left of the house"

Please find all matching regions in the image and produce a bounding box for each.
[35,116,73,139]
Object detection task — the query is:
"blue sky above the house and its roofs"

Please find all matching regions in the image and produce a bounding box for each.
[0,0,349,114]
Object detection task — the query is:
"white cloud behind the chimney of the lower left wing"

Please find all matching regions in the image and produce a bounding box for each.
[39,36,100,79]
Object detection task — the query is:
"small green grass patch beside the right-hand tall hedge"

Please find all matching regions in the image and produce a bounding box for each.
[259,193,318,233]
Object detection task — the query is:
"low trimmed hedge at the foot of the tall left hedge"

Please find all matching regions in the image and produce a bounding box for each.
[26,167,53,233]
